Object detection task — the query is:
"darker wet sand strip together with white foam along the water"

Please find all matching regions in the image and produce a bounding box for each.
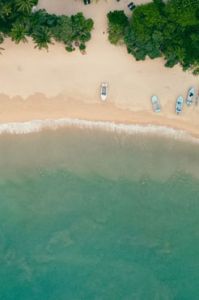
[0,94,199,143]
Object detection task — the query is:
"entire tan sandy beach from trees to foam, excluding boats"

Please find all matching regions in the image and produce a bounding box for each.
[0,0,199,137]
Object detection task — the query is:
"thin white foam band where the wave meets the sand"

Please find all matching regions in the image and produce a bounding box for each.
[0,118,199,143]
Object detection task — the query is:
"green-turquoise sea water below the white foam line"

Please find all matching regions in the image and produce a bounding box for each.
[0,128,199,300]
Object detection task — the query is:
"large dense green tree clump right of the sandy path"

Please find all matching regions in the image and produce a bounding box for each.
[108,0,199,74]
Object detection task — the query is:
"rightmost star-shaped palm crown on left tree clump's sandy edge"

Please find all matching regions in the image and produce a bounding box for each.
[31,27,52,49]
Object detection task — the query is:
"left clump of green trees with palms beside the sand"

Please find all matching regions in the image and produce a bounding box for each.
[0,0,93,51]
